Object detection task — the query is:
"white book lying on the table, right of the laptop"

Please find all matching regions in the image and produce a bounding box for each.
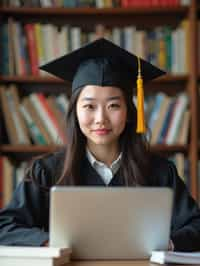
[150,251,200,264]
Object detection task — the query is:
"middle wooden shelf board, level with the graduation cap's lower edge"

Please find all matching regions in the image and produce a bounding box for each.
[0,74,189,84]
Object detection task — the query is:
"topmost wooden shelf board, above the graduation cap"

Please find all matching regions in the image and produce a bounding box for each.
[0,6,189,28]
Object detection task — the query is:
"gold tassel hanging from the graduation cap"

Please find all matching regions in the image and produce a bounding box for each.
[136,57,146,134]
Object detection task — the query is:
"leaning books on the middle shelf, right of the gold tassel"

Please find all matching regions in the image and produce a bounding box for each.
[146,93,190,145]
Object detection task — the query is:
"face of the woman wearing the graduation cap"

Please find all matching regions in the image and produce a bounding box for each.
[76,85,127,148]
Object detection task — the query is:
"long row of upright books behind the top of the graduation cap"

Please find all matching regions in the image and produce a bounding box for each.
[0,18,191,76]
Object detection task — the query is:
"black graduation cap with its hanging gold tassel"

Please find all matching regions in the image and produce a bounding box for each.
[40,38,165,133]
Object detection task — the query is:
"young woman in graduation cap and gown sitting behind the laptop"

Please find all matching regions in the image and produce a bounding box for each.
[0,39,200,251]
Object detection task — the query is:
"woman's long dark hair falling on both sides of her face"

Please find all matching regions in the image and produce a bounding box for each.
[57,88,149,186]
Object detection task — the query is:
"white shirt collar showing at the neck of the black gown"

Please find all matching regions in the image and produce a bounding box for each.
[86,148,122,185]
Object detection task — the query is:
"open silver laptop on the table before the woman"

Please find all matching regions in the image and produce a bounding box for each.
[50,187,173,260]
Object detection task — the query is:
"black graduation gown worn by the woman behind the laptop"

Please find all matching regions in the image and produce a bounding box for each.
[0,151,200,251]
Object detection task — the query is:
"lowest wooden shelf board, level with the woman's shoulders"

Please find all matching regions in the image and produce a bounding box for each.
[0,144,188,155]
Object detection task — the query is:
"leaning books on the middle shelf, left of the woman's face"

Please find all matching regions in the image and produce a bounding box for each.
[0,85,68,145]
